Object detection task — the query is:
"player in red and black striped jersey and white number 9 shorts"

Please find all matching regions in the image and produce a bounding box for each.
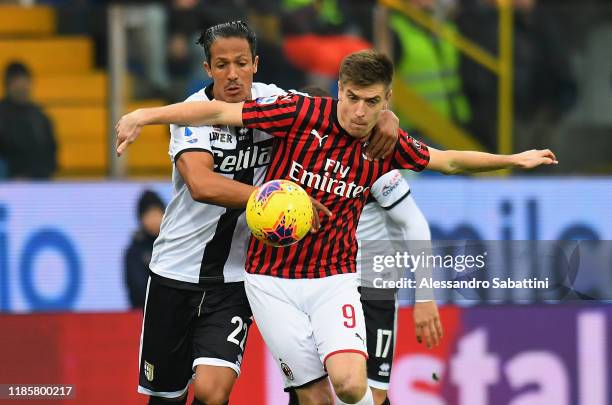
[117,51,556,404]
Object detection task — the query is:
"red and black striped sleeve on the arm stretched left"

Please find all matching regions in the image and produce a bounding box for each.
[242,93,303,137]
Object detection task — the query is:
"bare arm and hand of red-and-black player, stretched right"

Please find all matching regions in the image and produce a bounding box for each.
[427,147,559,174]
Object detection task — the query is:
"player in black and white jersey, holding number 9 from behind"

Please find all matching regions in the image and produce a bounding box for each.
[126,21,397,404]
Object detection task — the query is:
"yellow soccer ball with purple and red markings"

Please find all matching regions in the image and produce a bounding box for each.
[246,180,312,246]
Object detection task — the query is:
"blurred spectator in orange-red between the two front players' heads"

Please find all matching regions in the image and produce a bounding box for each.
[281,0,372,88]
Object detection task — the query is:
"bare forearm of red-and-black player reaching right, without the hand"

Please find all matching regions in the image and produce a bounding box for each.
[445,150,515,174]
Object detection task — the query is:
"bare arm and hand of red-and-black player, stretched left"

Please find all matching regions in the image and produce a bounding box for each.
[115,100,244,156]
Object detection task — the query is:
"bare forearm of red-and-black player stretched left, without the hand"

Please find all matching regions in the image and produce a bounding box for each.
[137,101,242,126]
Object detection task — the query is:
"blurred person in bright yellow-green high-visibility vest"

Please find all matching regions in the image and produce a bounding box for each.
[389,0,471,131]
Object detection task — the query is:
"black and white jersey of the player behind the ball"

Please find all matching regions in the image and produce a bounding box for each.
[149,83,285,288]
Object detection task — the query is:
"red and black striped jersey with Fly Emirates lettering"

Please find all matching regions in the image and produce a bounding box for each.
[242,94,429,278]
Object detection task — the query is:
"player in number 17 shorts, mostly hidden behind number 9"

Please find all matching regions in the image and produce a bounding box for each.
[289,86,442,405]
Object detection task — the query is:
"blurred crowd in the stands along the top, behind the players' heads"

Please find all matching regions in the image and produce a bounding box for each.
[0,0,612,178]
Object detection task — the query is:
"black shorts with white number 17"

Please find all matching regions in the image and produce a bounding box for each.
[360,287,397,390]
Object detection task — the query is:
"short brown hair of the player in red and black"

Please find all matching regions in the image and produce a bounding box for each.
[340,50,393,87]
